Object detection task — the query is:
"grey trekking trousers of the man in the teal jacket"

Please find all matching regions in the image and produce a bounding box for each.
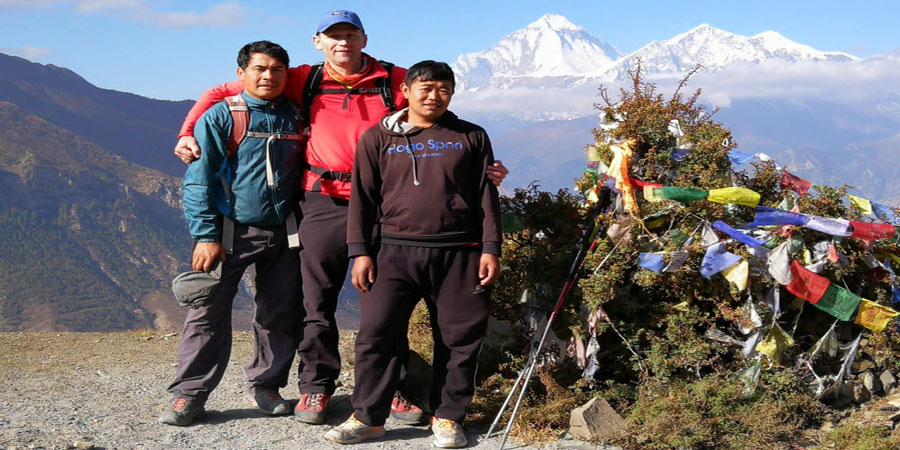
[167,223,302,399]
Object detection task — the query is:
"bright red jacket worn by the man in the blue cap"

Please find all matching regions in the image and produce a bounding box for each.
[178,53,408,199]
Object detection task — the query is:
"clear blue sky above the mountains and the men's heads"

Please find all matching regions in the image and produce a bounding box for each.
[0,0,900,99]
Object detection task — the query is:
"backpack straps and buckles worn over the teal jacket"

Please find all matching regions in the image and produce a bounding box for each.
[220,94,304,255]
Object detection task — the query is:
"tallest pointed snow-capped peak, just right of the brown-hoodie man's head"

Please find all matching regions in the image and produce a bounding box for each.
[453,14,623,89]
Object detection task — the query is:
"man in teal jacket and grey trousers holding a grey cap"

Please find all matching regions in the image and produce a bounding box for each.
[159,41,302,426]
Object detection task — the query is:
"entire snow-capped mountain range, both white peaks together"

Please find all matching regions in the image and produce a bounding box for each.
[453,14,859,90]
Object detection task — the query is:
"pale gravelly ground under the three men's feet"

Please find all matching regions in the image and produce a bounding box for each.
[0,331,552,450]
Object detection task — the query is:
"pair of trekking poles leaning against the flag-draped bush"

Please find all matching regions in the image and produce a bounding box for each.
[486,186,610,450]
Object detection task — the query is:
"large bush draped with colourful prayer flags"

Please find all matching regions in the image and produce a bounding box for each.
[571,67,900,396]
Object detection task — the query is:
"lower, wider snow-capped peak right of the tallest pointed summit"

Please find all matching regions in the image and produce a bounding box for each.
[584,23,859,84]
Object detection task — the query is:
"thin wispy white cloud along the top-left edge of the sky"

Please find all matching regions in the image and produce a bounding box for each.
[0,0,259,28]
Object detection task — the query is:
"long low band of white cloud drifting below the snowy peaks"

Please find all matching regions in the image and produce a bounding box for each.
[452,55,900,122]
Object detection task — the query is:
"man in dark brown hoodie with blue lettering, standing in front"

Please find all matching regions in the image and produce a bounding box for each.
[326,61,501,448]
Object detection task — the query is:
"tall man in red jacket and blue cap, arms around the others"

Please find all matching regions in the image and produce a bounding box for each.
[169,10,508,423]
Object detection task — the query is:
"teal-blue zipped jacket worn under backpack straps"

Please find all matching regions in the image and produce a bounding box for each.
[184,93,303,242]
